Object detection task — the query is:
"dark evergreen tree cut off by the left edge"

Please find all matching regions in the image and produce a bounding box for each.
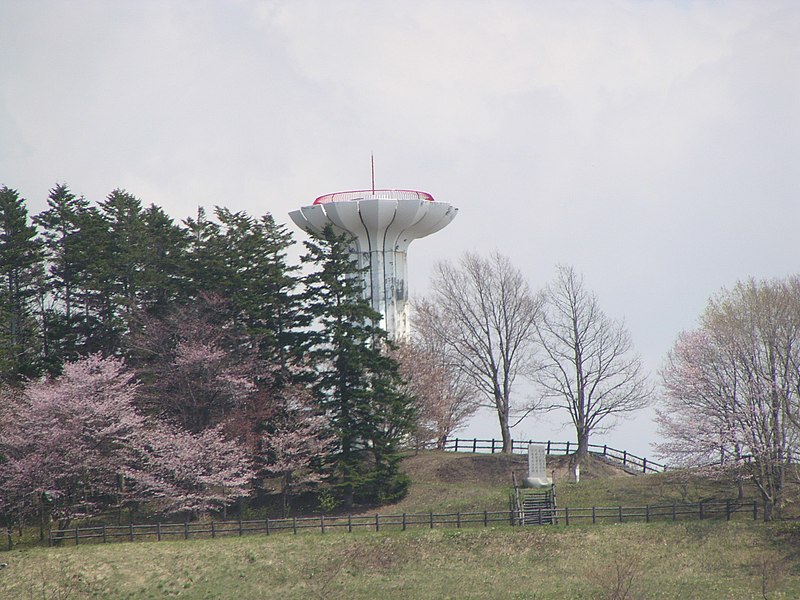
[0,186,42,382]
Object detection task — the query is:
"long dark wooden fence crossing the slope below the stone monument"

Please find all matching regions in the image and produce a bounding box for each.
[47,500,759,546]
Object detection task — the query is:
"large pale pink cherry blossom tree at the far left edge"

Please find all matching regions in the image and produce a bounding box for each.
[0,355,145,523]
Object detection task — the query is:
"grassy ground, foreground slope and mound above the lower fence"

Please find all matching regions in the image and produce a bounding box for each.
[0,452,800,600]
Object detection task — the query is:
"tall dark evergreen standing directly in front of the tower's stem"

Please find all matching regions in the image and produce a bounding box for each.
[303,226,413,508]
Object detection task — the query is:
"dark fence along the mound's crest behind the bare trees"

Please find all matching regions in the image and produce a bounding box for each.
[443,438,667,473]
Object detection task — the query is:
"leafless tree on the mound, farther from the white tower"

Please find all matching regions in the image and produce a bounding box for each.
[536,265,651,470]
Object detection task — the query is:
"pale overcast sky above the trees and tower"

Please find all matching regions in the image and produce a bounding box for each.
[0,0,800,456]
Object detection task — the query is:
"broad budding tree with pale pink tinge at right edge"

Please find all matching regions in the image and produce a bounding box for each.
[659,277,800,520]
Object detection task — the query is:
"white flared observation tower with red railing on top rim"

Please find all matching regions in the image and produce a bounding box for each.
[289,189,458,340]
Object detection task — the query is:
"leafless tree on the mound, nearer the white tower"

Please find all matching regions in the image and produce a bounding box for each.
[416,253,541,453]
